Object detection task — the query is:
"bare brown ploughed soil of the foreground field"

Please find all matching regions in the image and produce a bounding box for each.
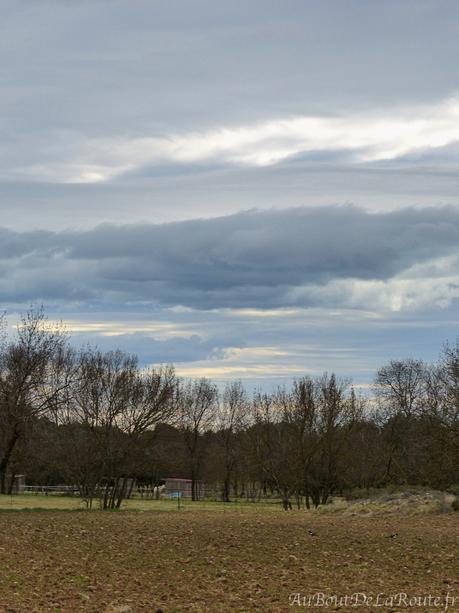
[0,511,459,613]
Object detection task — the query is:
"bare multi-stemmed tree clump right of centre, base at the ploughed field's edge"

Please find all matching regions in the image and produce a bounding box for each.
[253,375,361,510]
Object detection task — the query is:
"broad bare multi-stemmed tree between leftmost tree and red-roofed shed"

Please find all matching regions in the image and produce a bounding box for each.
[55,349,176,509]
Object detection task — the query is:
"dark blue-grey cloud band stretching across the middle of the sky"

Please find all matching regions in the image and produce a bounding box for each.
[0,206,459,309]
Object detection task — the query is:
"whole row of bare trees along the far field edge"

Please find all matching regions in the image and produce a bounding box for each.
[0,309,459,509]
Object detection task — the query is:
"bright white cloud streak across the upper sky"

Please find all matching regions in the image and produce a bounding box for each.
[2,97,459,183]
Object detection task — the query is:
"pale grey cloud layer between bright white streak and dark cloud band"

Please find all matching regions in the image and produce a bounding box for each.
[0,160,458,230]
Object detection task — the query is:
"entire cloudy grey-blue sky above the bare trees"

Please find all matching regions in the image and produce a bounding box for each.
[0,0,459,389]
